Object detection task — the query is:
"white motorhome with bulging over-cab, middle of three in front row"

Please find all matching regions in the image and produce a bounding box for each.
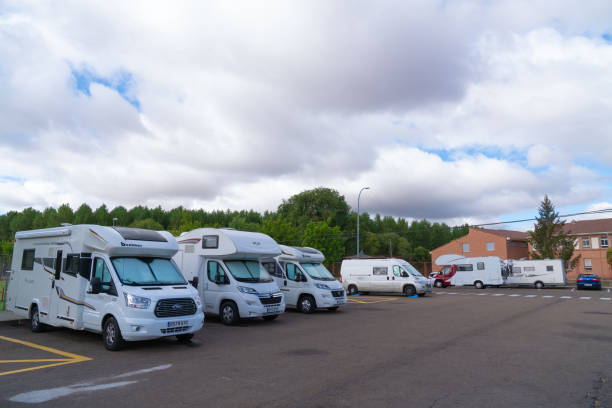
[174,228,285,325]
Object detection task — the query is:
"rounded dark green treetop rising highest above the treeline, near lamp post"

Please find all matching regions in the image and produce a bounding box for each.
[278,187,349,229]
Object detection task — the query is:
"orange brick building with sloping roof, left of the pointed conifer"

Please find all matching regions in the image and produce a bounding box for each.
[431,227,529,269]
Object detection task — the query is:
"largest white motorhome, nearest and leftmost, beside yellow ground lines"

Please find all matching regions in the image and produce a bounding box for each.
[7,225,204,350]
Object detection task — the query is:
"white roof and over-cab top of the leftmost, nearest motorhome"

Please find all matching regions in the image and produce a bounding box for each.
[15,224,178,258]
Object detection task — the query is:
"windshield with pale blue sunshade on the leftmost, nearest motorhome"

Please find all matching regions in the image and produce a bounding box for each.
[112,257,187,286]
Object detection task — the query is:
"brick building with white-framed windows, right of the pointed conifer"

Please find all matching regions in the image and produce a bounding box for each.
[529,218,612,279]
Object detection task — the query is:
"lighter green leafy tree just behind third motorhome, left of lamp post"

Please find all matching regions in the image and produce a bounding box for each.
[302,217,345,266]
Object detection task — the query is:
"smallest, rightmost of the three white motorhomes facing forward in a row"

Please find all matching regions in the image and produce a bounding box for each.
[262,245,346,313]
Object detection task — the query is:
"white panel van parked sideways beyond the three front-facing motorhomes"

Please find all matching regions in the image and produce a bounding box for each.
[340,258,431,296]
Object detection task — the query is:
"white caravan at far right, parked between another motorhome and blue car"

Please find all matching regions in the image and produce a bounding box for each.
[503,259,566,289]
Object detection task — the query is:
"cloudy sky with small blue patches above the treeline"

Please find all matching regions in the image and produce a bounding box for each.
[0,0,612,225]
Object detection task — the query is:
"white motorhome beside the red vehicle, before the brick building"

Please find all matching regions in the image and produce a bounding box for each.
[435,254,504,289]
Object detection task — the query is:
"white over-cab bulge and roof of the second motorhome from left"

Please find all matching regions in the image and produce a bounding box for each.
[178,228,281,259]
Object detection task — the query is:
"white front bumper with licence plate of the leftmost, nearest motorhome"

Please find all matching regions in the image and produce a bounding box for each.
[120,312,204,341]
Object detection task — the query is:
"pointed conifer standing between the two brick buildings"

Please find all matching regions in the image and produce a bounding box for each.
[528,195,580,269]
